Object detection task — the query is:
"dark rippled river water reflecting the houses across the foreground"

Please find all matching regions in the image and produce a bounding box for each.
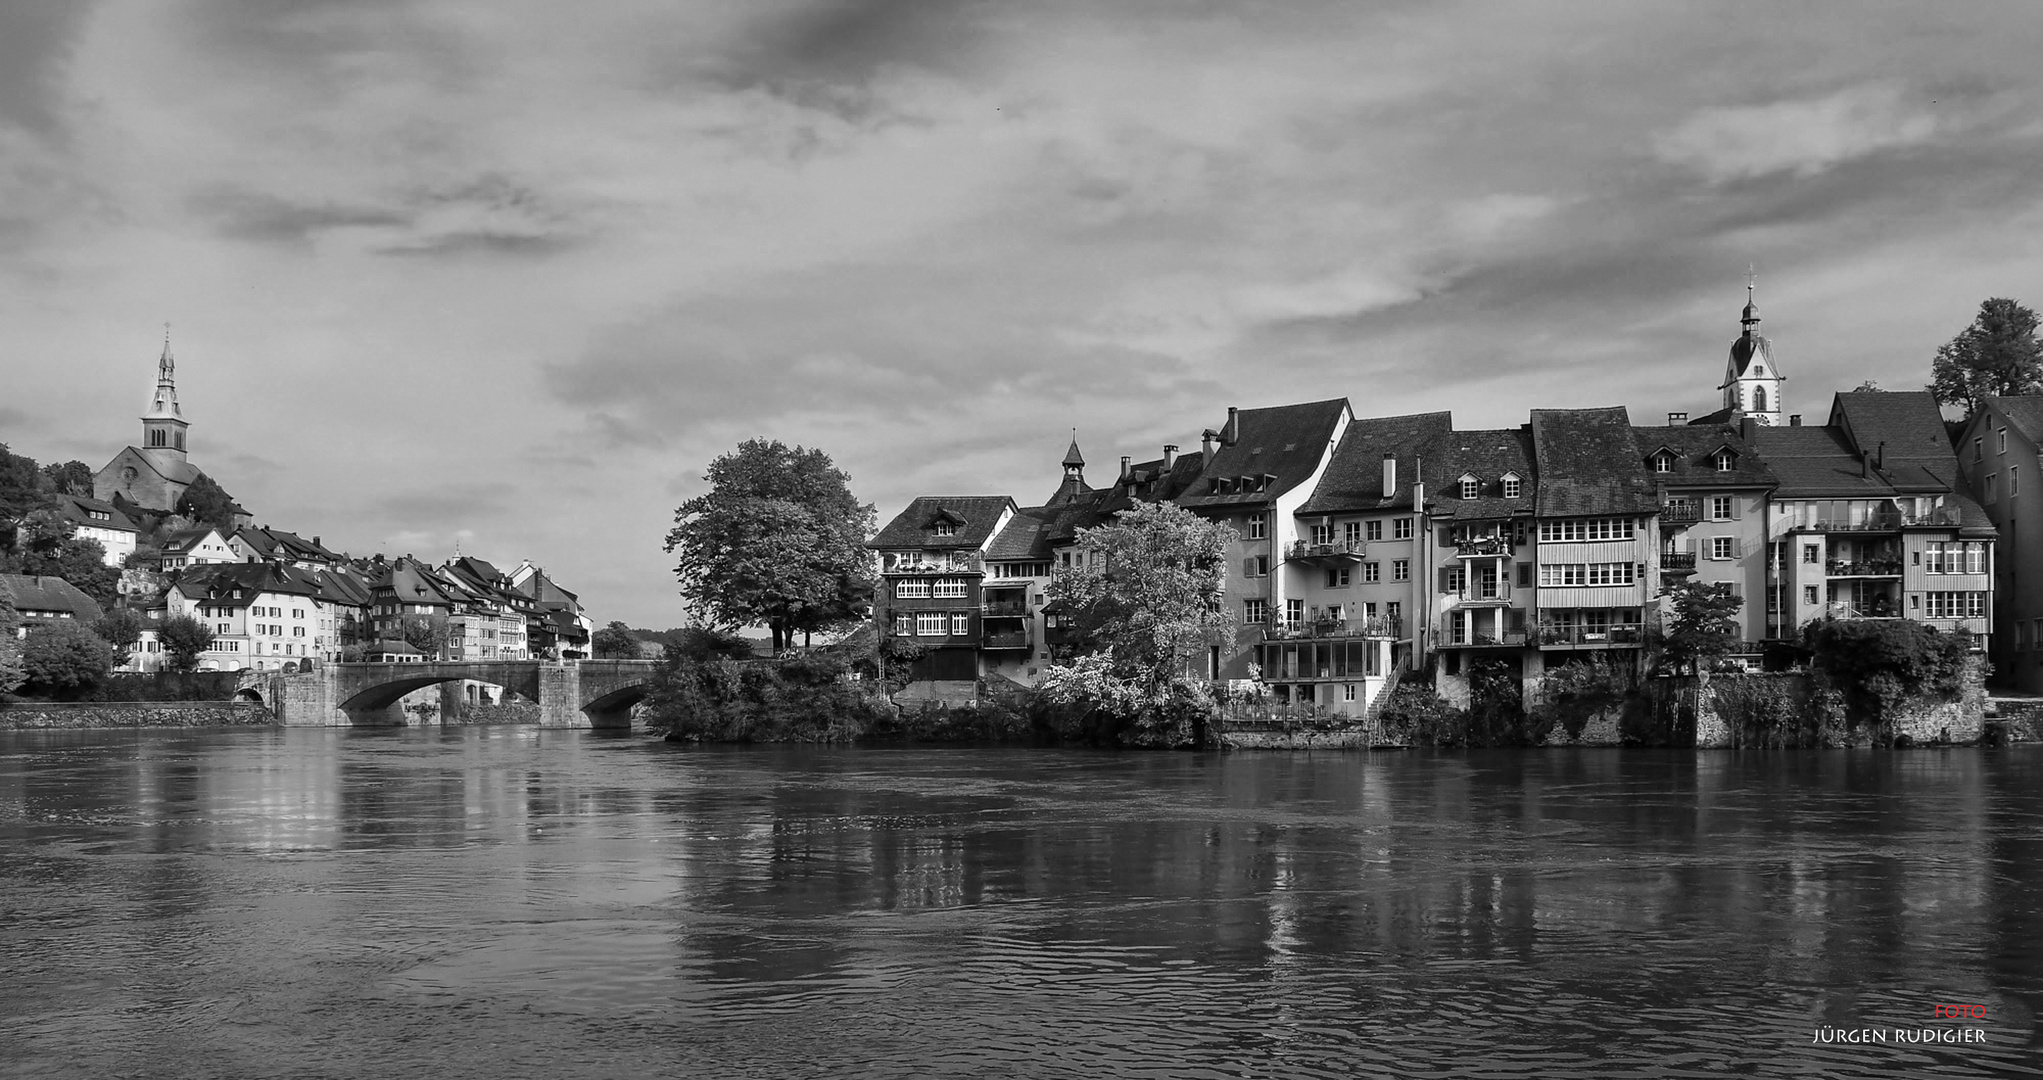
[0,727,2043,1080]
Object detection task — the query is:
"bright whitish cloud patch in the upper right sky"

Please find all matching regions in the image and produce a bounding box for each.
[1653,84,1939,184]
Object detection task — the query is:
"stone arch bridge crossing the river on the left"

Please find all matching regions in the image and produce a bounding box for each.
[266,659,660,729]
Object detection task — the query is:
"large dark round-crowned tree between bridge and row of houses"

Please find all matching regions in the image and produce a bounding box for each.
[666,439,874,651]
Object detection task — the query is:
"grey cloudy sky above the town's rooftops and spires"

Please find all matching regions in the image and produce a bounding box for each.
[0,0,2043,627]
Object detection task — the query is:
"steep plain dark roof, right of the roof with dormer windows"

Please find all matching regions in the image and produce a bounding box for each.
[1532,406,1657,517]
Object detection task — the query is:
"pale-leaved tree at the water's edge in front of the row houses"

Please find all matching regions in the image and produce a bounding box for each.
[1042,502,1234,743]
